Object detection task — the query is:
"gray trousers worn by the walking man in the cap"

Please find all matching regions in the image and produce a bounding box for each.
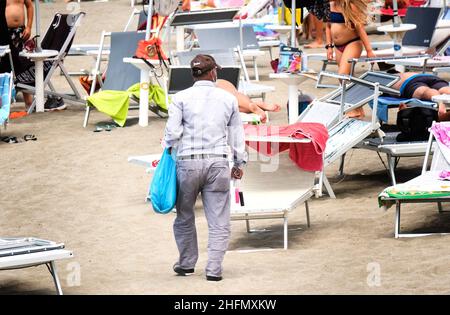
[173,158,231,276]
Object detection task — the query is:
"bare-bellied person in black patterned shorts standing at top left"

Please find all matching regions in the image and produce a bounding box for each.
[6,0,34,109]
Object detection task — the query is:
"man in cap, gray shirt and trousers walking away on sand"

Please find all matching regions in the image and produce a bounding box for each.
[164,55,247,281]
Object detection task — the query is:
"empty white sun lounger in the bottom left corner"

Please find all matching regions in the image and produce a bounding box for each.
[0,238,73,295]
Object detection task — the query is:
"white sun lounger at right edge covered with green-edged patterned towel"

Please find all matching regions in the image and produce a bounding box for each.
[379,122,450,238]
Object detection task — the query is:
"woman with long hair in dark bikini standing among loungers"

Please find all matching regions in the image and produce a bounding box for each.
[325,0,375,117]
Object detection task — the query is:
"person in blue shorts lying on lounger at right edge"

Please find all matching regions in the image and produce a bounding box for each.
[392,72,450,121]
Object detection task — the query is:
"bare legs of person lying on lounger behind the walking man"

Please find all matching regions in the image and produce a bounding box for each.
[216,79,281,123]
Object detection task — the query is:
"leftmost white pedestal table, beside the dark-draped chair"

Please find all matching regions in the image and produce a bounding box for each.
[20,49,59,112]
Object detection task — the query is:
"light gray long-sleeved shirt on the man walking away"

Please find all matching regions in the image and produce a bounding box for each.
[164,81,247,166]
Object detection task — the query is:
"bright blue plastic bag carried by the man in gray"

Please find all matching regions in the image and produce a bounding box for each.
[149,149,177,214]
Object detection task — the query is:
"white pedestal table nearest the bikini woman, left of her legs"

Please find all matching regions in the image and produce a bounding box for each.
[269,72,317,124]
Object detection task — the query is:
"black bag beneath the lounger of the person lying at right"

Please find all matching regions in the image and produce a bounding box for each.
[397,106,438,142]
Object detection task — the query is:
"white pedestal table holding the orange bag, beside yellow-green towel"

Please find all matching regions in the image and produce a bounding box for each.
[123,57,163,127]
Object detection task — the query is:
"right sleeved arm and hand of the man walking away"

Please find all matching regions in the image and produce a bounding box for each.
[228,99,247,178]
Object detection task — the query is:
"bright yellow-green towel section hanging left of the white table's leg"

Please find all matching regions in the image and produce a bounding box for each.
[87,90,130,127]
